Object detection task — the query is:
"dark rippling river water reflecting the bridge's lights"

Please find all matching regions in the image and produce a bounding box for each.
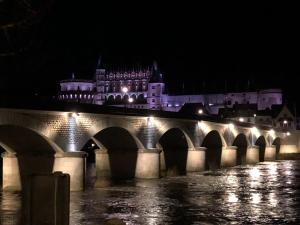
[0,161,300,225]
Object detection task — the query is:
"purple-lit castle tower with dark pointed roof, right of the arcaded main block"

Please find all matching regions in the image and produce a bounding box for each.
[147,61,165,109]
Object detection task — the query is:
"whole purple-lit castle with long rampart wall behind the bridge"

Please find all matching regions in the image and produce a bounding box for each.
[59,59,282,114]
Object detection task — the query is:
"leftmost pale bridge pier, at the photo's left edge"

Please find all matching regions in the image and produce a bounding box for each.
[1,152,22,191]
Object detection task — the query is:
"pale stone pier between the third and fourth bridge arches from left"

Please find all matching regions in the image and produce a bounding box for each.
[186,147,206,172]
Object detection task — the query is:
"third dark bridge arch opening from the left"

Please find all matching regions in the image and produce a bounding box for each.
[157,128,194,176]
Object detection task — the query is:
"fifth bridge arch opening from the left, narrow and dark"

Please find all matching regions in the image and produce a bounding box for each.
[232,133,249,165]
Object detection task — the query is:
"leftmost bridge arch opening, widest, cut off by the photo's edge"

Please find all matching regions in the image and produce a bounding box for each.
[0,125,62,189]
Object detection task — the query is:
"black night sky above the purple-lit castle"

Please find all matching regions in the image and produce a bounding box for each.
[0,0,300,103]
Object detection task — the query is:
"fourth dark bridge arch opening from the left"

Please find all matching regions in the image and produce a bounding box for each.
[202,130,226,170]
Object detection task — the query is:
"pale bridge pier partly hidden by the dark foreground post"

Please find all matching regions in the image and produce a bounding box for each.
[53,151,86,191]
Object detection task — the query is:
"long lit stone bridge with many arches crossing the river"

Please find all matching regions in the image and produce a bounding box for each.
[0,106,300,190]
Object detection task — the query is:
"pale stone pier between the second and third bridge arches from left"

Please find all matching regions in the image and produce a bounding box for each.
[135,148,161,179]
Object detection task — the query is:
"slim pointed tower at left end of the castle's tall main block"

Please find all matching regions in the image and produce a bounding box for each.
[95,56,105,105]
